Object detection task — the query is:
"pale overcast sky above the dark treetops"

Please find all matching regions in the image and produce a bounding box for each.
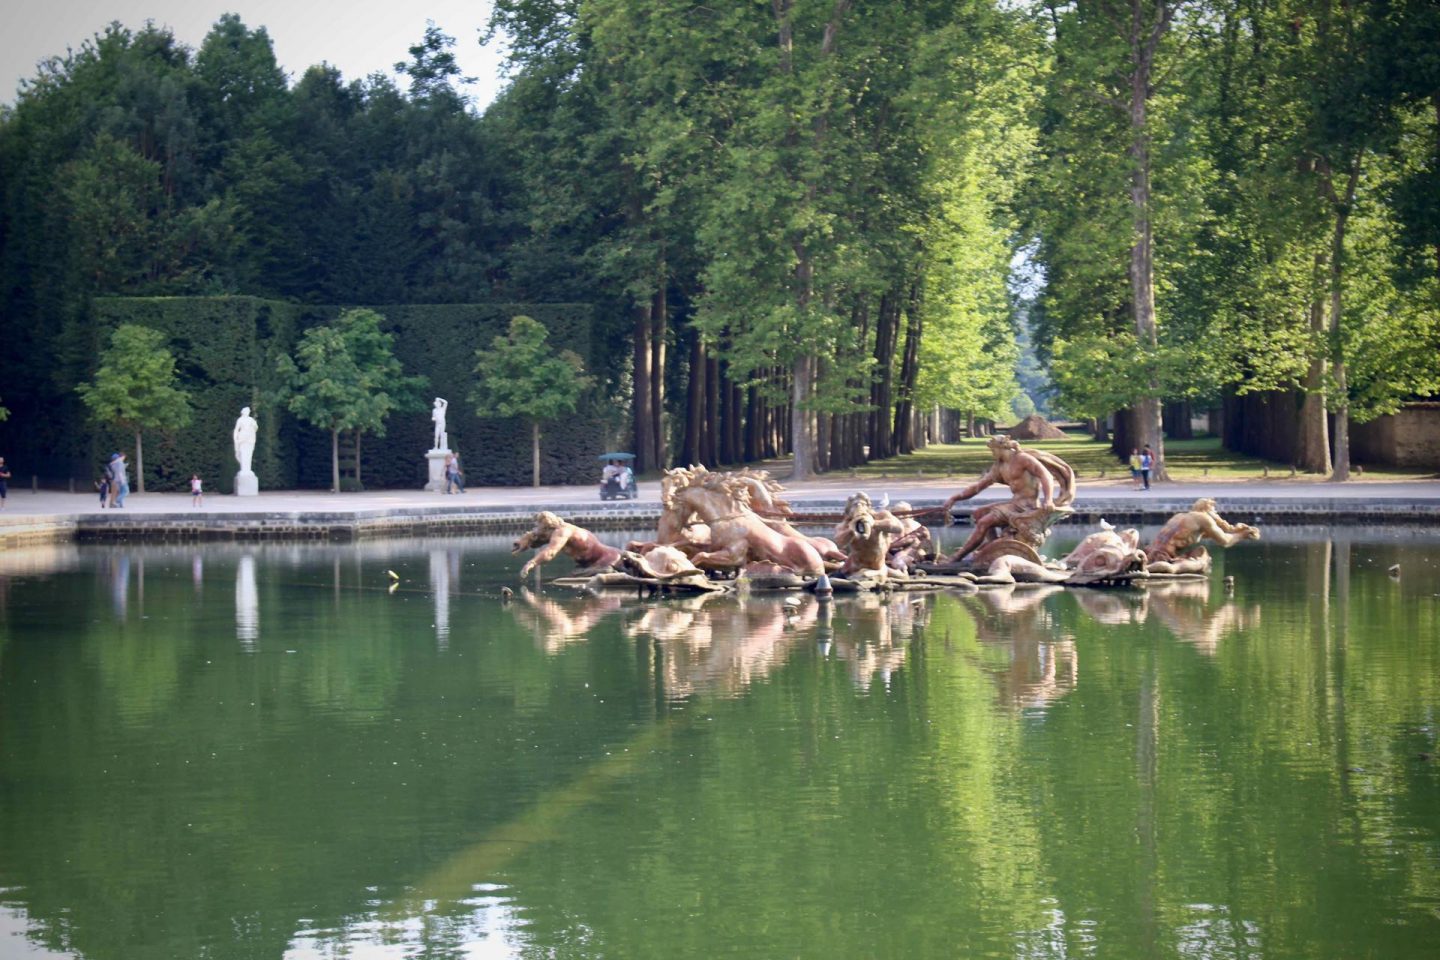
[0,0,512,107]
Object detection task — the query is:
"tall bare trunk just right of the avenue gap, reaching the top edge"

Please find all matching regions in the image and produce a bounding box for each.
[1129,0,1175,479]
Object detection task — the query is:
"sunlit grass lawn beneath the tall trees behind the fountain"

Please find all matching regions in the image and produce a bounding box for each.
[855,433,1436,481]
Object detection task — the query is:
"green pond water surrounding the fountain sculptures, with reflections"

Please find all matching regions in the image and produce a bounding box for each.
[0,530,1440,960]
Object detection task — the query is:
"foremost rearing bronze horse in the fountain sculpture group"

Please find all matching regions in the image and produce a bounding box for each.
[664,466,825,577]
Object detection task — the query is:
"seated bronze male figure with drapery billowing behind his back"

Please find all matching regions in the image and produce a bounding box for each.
[945,436,1076,563]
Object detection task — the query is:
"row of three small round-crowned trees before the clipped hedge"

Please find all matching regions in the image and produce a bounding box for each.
[76,315,592,494]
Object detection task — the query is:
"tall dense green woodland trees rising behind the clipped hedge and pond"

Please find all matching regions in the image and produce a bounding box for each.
[0,0,1440,484]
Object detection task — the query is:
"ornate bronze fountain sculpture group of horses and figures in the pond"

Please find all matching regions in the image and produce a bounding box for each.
[513,436,1260,590]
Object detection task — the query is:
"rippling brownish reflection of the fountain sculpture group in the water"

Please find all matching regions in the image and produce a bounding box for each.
[507,581,1260,710]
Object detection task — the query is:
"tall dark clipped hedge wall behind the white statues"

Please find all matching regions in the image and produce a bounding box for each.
[0,296,606,492]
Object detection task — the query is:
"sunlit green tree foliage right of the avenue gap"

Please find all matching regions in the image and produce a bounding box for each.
[1027,0,1440,475]
